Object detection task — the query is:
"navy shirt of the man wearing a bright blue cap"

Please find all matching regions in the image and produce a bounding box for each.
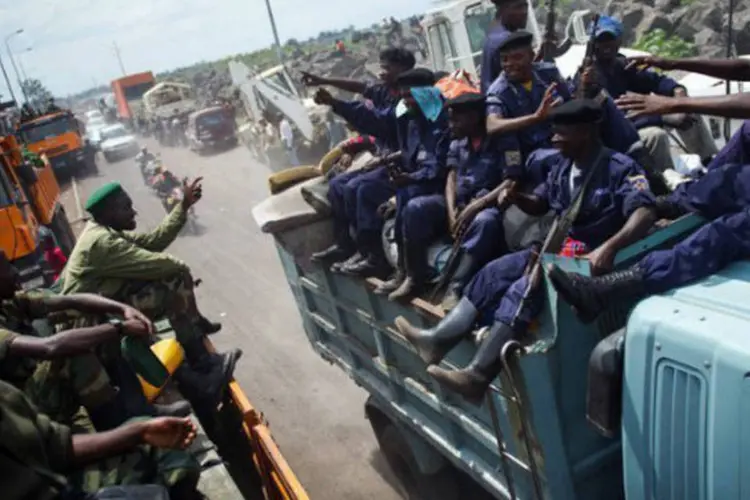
[596,55,680,128]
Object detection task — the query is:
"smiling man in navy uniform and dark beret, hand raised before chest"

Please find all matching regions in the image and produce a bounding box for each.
[487,31,640,161]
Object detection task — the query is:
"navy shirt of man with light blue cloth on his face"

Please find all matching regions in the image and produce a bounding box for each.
[332,97,450,184]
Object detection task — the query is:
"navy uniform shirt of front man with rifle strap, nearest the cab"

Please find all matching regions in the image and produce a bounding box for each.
[534,148,655,249]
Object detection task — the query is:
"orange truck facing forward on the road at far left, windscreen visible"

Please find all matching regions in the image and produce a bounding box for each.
[16,110,96,179]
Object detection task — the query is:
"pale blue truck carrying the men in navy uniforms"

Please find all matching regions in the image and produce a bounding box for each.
[253,143,750,500]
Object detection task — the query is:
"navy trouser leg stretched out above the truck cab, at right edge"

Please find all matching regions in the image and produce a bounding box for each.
[639,209,750,294]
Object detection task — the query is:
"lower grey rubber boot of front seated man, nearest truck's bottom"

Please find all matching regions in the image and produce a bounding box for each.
[427,322,513,405]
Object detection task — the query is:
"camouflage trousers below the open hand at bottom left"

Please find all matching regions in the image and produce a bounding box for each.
[70,418,201,498]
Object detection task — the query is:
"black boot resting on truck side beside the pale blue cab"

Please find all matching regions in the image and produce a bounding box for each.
[549,265,646,323]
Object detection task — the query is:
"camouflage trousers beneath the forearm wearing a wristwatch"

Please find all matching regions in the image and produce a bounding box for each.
[23,353,117,424]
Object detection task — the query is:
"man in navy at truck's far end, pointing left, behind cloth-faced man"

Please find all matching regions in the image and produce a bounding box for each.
[303,48,415,272]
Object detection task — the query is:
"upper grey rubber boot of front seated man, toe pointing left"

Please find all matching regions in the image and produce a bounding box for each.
[395,298,479,365]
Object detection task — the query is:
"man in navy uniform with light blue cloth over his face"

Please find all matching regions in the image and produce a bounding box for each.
[316,68,449,284]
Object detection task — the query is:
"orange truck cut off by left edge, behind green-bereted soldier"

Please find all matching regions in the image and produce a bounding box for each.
[0,135,75,288]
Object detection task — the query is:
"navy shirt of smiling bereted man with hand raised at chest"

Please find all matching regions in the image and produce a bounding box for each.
[487,63,570,160]
